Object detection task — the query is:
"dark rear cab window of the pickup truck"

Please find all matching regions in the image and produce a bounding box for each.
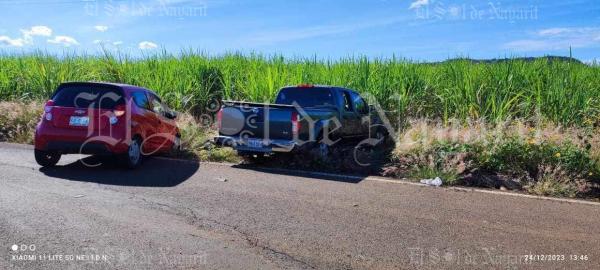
[275,87,335,107]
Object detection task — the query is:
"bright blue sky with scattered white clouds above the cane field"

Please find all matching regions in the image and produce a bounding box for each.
[0,0,600,62]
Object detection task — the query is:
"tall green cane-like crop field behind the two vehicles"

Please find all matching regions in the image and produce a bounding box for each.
[0,51,600,126]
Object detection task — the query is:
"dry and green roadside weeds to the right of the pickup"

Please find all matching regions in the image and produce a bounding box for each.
[388,120,600,197]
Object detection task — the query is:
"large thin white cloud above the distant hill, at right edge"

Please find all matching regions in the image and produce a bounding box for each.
[504,27,600,51]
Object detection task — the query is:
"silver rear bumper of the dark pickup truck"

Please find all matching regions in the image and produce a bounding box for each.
[215,136,297,153]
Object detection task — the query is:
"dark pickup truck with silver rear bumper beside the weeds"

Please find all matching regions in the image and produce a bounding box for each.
[215,84,387,156]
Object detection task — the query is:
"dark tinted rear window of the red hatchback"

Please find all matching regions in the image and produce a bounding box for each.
[52,85,125,110]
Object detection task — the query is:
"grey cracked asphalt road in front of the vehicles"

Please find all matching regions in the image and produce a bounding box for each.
[0,144,600,269]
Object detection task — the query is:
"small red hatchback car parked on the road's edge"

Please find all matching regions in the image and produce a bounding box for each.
[35,82,180,168]
